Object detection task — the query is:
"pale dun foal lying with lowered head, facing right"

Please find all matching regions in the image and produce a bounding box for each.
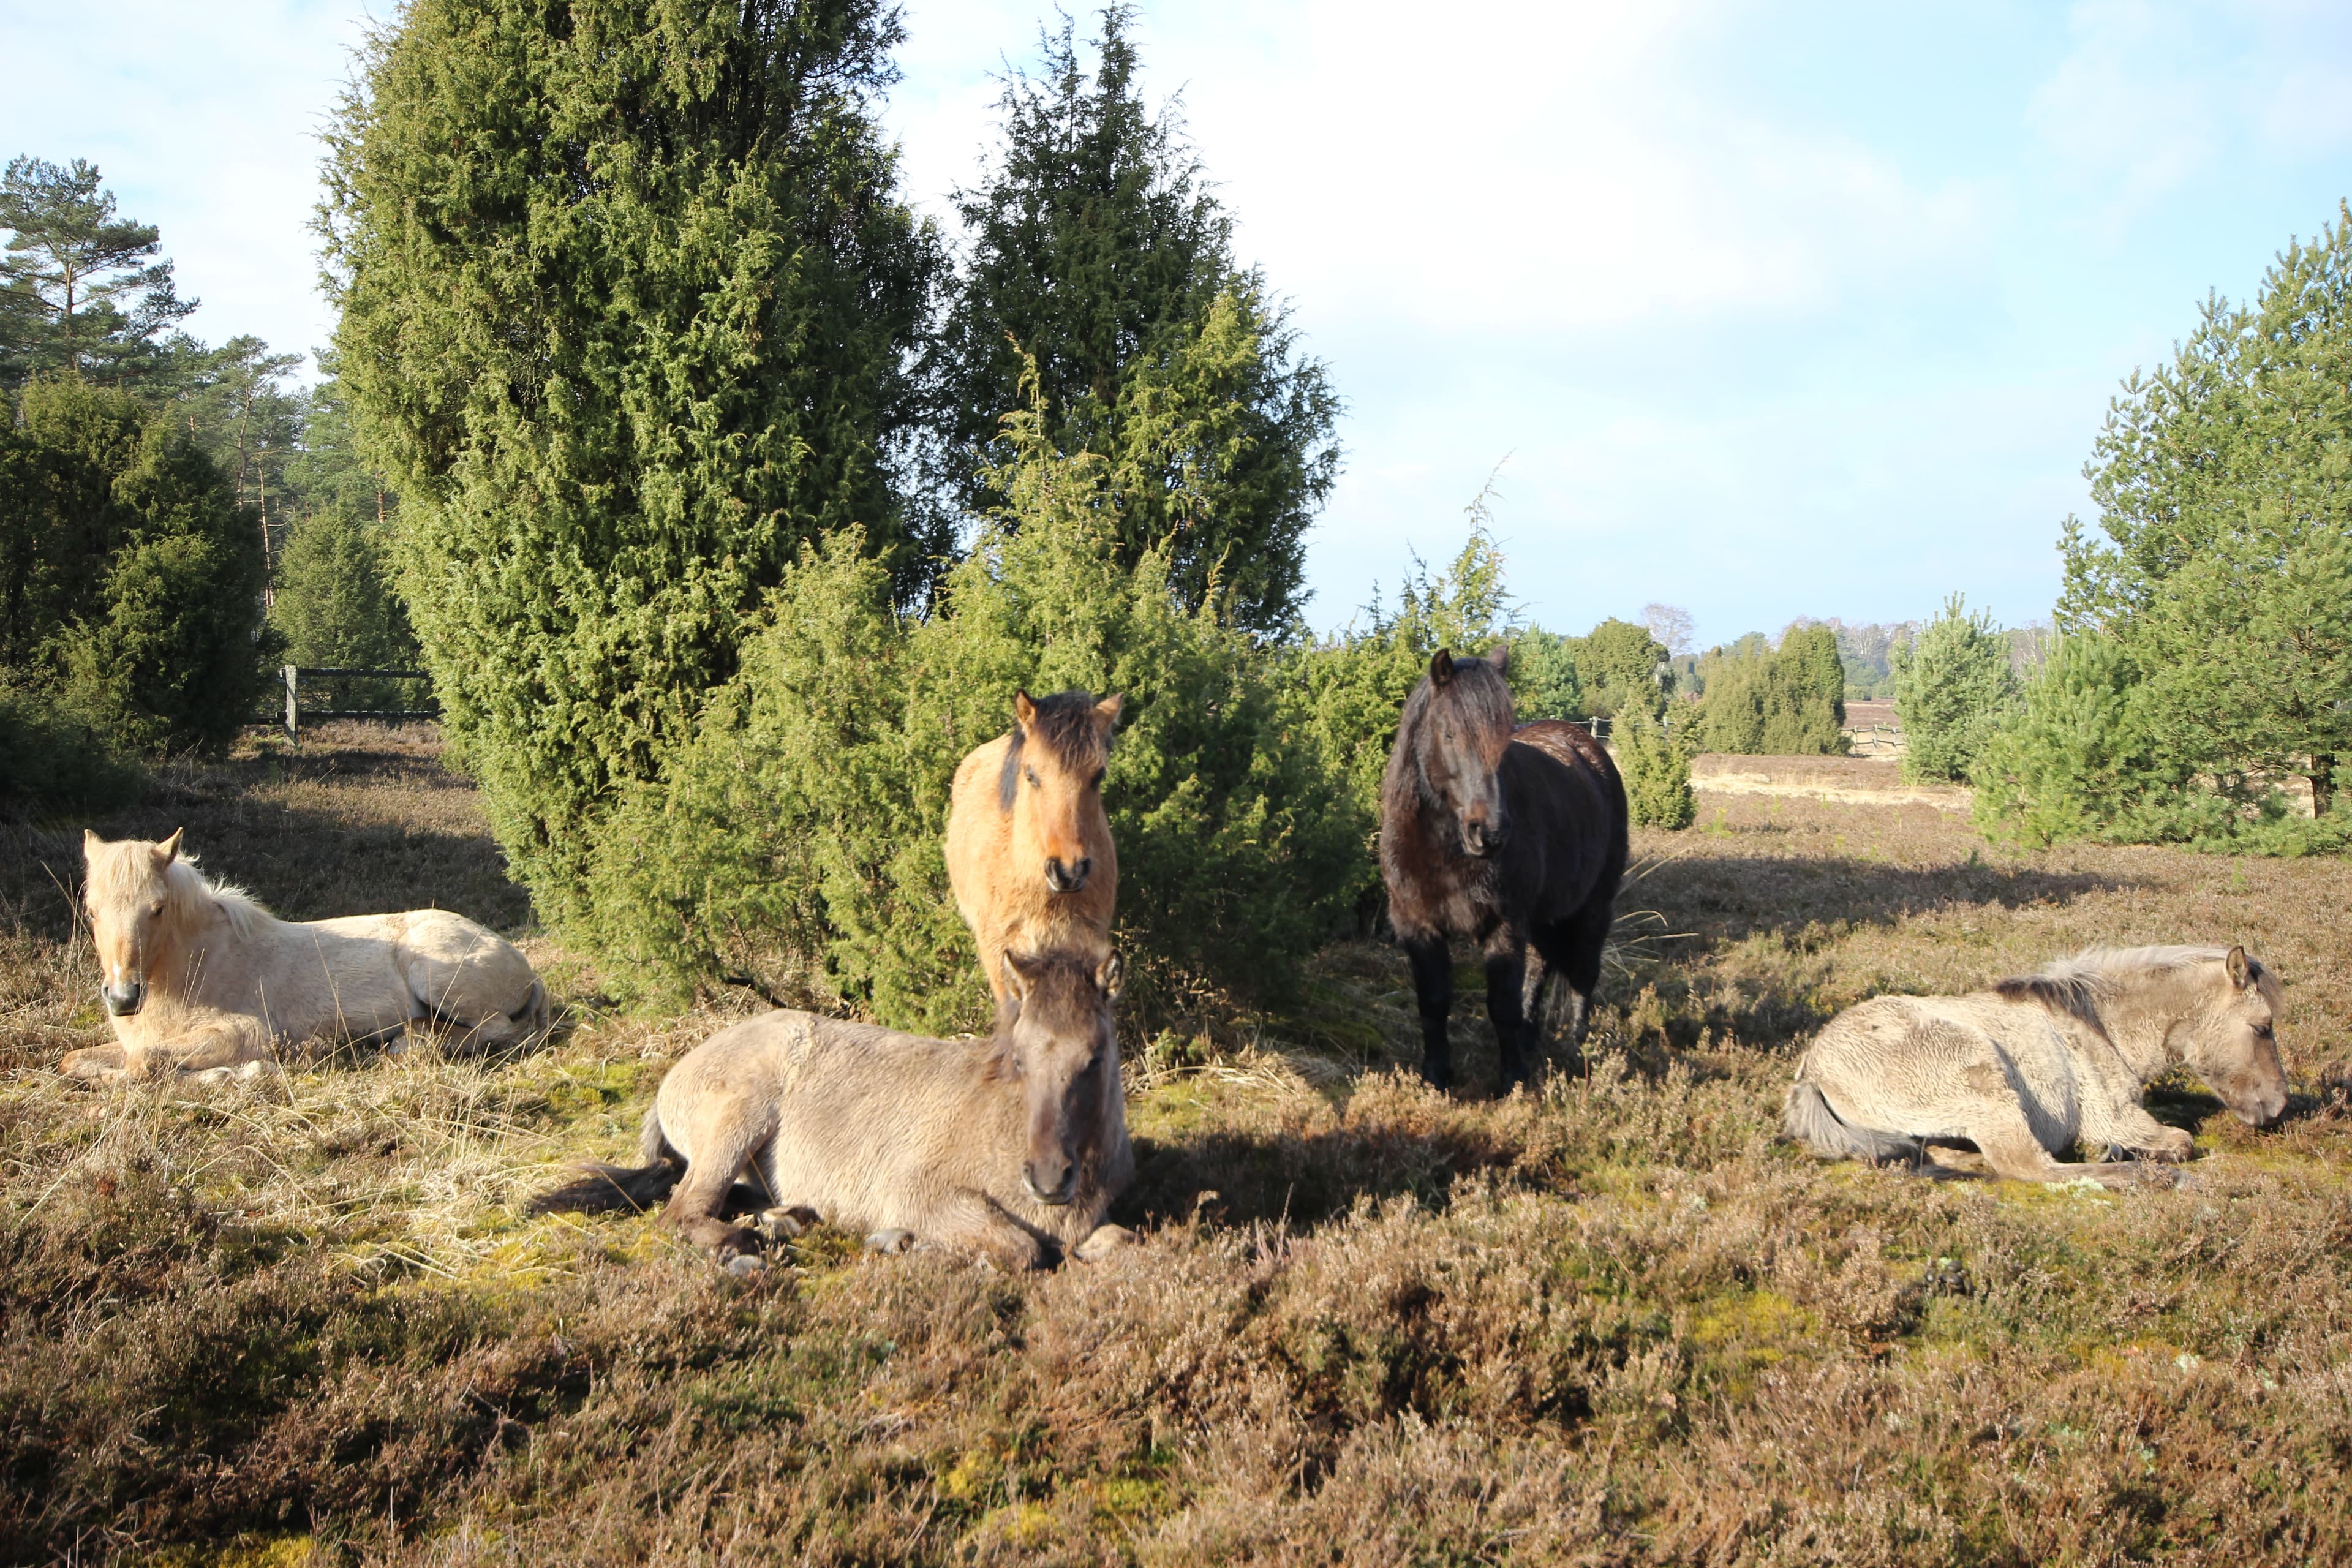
[1785,948,2286,1185]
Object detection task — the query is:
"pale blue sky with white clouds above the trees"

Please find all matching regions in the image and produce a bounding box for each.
[0,0,2352,644]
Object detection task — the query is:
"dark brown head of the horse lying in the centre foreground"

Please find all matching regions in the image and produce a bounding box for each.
[1000,952,1122,1208]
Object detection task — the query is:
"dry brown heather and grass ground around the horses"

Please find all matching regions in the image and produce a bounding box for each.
[0,731,2352,1563]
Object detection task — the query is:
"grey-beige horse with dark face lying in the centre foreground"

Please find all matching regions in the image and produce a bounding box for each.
[532,952,1134,1270]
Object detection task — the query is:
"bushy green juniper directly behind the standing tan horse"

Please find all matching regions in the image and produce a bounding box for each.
[590,399,1362,1030]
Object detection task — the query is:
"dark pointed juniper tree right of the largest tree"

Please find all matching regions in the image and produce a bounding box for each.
[932,5,1338,628]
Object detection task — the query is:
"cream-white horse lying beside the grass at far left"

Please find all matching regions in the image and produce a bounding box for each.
[61,832,548,1079]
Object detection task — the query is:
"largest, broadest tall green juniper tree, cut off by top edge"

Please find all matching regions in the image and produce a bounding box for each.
[322,0,950,919]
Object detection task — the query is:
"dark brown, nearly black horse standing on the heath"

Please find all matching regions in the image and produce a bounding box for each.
[1381,646,1625,1093]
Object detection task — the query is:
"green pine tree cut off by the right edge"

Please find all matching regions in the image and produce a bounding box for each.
[2058,207,2352,811]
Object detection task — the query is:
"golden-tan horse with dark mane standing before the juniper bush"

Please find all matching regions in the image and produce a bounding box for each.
[948,691,1122,1009]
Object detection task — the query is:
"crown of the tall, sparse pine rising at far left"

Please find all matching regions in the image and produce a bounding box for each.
[0,155,198,388]
